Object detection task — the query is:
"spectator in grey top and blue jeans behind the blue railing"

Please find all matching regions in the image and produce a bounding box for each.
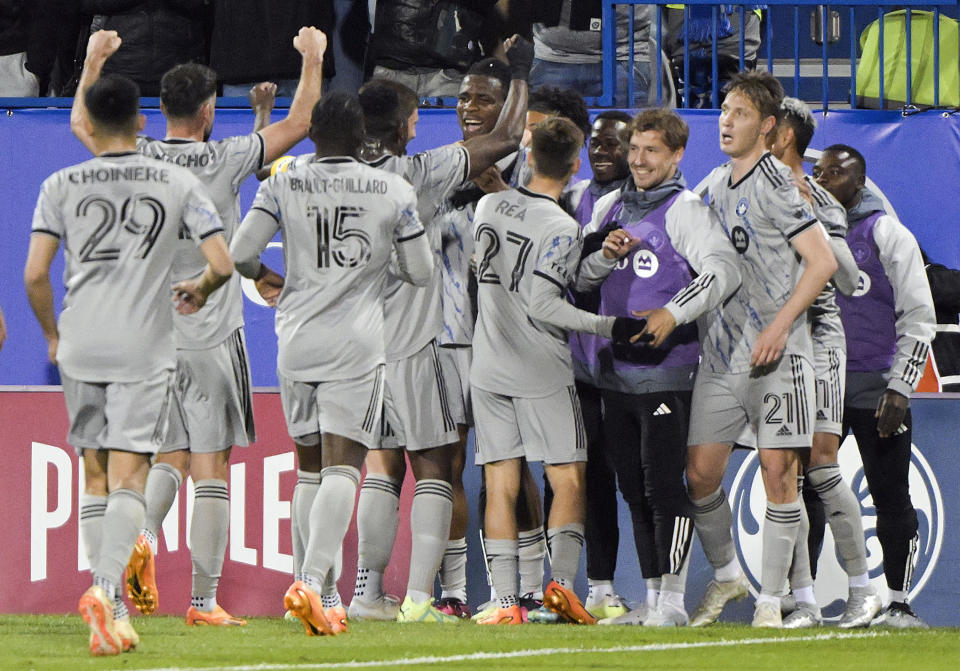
[530,0,673,107]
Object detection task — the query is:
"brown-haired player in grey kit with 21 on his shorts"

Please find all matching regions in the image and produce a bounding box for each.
[687,72,837,627]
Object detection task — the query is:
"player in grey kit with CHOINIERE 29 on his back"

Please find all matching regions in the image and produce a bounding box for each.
[24,76,233,655]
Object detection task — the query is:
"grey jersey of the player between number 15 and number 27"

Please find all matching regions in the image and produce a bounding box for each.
[371,145,470,361]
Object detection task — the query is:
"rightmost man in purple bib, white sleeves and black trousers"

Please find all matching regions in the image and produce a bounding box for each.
[813,145,936,628]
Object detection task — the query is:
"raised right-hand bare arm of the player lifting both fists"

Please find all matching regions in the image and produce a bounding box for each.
[260,26,327,163]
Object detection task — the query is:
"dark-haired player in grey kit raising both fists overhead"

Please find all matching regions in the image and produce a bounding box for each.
[71,28,326,626]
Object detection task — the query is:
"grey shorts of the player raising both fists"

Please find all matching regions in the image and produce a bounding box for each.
[160,329,256,454]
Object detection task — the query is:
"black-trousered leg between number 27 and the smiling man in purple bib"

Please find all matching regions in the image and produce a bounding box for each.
[575,382,627,619]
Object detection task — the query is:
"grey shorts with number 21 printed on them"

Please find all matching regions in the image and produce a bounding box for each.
[687,354,816,449]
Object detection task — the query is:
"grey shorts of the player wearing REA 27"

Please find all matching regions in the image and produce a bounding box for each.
[473,385,587,465]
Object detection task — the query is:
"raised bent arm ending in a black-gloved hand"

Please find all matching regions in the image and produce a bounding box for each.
[463,35,533,179]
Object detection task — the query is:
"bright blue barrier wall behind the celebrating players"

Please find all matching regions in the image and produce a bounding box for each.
[0,109,960,386]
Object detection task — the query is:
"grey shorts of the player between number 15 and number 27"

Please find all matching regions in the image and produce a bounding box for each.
[381,340,457,452]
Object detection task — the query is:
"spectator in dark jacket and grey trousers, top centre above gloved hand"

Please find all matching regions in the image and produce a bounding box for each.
[367,0,499,98]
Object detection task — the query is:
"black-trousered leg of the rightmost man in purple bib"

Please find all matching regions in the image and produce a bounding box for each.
[847,408,926,628]
